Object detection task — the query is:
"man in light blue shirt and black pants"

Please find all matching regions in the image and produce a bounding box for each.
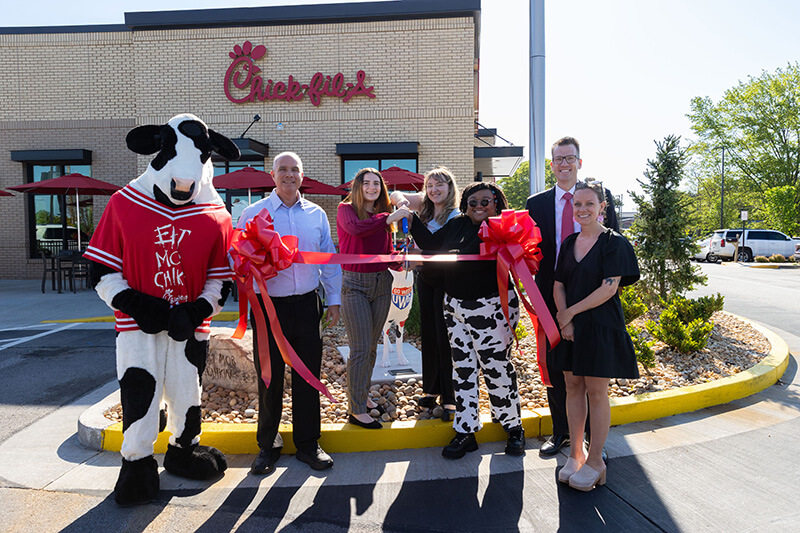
[238,152,342,475]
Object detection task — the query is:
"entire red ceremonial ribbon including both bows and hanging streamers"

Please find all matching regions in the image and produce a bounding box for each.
[230,209,561,394]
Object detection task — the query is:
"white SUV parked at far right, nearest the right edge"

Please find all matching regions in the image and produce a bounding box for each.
[710,229,795,262]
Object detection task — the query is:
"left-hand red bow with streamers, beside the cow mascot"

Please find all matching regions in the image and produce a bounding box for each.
[230,209,336,402]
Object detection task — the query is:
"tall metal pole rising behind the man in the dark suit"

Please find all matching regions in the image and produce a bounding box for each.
[529,0,544,194]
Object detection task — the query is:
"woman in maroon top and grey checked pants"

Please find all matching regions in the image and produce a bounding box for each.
[336,168,411,429]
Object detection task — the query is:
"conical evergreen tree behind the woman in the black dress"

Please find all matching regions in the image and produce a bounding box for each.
[630,135,706,300]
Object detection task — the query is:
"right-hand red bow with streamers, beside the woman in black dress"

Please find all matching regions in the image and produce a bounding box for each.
[478,209,561,387]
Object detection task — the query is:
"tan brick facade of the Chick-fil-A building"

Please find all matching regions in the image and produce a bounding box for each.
[0,13,477,279]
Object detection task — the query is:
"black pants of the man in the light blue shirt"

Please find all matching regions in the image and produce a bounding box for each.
[250,291,322,453]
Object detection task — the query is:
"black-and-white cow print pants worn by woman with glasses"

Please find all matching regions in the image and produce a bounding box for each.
[444,290,522,433]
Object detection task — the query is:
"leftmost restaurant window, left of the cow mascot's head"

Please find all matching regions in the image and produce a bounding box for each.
[28,163,94,257]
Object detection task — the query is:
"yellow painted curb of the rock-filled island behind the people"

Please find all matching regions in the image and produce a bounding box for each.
[102,315,789,455]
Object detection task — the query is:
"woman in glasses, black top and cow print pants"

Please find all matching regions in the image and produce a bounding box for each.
[411,182,525,459]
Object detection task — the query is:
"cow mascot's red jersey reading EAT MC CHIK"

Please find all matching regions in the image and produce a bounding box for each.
[85,185,232,333]
